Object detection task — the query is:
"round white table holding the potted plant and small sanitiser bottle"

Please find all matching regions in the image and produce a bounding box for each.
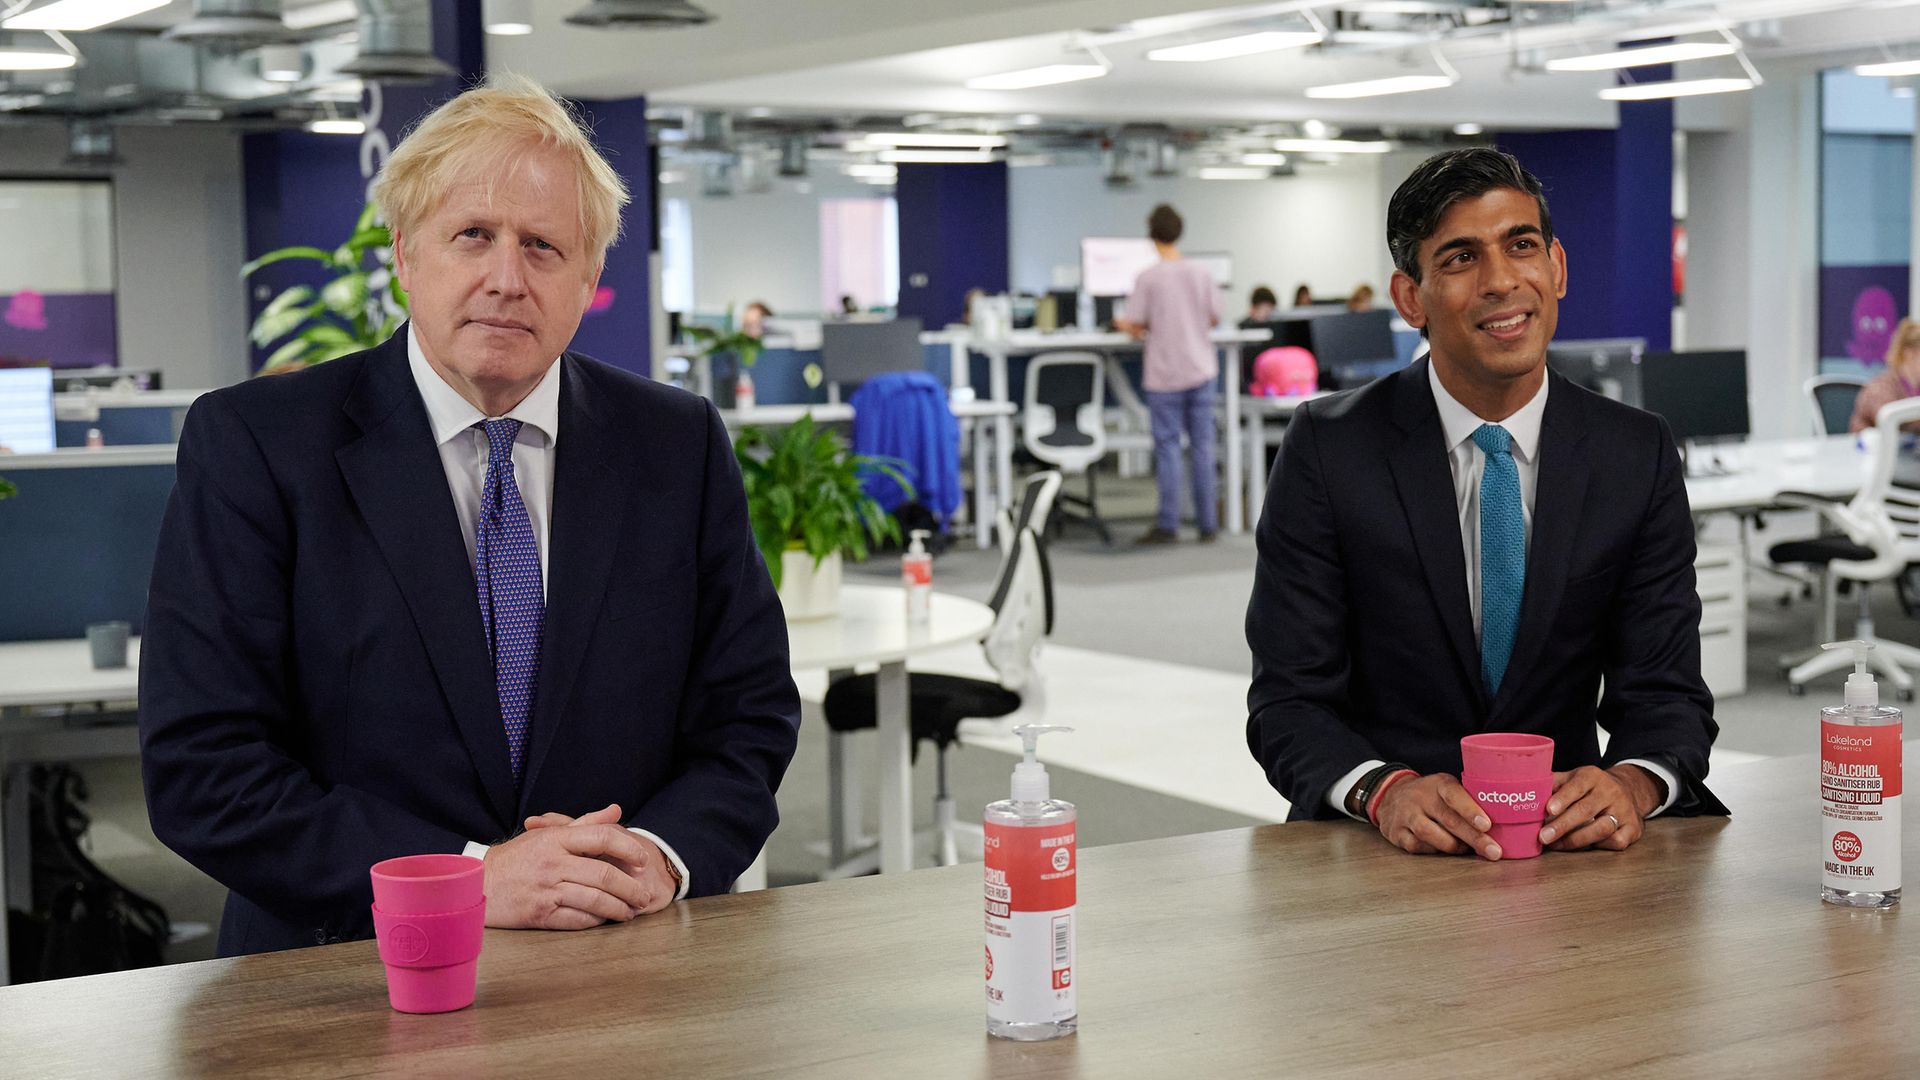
[787,584,993,874]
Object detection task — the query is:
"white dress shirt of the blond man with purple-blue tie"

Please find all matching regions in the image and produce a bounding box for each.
[407,323,693,899]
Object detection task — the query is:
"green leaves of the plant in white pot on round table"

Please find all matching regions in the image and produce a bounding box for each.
[733,417,914,588]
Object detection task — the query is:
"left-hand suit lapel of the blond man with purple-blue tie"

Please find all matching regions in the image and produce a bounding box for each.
[334,331,515,822]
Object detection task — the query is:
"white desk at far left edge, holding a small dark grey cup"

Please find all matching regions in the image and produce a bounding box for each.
[0,638,140,986]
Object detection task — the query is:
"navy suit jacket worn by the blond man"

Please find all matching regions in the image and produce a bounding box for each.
[140,331,801,955]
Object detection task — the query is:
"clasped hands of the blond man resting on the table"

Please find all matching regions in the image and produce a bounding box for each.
[486,803,680,930]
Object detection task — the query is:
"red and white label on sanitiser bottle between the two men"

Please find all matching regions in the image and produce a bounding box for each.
[987,821,1079,1024]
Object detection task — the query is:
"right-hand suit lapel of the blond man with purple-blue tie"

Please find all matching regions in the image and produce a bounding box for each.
[520,356,632,815]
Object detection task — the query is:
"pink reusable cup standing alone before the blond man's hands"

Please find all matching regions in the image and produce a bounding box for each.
[372,855,486,1013]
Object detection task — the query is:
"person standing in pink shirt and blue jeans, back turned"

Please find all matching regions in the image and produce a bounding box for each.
[1116,204,1219,544]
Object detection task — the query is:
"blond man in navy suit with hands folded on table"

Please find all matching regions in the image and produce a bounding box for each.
[140,77,799,955]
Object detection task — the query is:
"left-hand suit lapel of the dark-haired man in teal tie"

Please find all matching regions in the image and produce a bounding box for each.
[1392,359,1484,700]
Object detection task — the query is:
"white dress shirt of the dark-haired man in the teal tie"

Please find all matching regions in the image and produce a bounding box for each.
[1327,359,1680,817]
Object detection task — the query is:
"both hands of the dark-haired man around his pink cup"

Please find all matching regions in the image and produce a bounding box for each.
[1375,765,1661,859]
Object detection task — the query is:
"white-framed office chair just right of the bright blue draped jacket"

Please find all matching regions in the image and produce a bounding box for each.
[1020,352,1114,546]
